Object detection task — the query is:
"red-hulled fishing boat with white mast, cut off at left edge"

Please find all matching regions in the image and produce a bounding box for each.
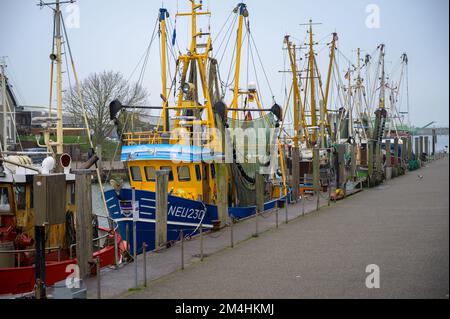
[0,0,121,298]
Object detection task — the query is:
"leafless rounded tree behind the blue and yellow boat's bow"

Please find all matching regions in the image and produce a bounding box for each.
[63,71,148,146]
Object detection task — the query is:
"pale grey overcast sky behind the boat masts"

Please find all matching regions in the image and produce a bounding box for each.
[0,0,449,126]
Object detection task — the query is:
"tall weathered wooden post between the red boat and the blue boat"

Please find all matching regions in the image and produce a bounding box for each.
[75,170,93,279]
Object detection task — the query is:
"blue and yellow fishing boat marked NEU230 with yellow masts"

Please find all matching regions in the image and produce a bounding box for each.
[105,1,288,253]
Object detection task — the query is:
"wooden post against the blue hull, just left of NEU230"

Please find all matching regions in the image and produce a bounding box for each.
[155,170,169,247]
